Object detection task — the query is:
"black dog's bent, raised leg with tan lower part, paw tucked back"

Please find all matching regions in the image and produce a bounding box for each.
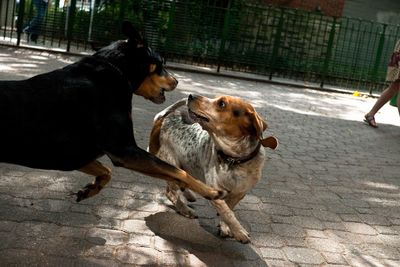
[75,160,111,202]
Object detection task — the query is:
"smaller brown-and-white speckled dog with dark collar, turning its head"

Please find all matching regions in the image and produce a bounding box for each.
[149,95,278,243]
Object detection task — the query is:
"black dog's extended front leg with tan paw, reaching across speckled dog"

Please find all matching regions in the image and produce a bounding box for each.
[106,146,227,199]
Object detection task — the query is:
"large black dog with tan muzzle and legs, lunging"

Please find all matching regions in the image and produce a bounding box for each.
[0,22,224,201]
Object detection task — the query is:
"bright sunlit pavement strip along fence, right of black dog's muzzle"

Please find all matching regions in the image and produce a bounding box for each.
[173,72,400,126]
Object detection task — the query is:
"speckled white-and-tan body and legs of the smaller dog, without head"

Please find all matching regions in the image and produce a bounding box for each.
[150,99,278,243]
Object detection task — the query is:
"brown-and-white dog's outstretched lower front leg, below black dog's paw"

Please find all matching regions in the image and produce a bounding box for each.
[211,200,250,243]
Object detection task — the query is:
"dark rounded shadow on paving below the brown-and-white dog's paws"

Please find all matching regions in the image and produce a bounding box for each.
[145,212,267,266]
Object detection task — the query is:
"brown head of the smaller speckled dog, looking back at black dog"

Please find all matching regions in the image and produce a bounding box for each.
[188,95,278,149]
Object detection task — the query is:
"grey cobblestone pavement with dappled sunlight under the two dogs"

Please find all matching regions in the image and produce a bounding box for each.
[0,47,400,266]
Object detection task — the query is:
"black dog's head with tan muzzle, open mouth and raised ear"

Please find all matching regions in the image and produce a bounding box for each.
[95,22,178,104]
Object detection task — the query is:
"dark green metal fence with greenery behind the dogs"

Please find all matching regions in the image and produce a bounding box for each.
[0,0,400,92]
